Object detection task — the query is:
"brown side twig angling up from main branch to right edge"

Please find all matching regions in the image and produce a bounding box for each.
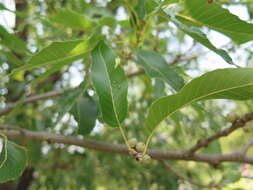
[187,112,253,154]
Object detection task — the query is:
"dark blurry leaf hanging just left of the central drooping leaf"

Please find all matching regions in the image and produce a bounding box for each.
[72,97,98,135]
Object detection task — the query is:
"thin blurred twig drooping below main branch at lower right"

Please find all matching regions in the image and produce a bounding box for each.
[161,161,220,188]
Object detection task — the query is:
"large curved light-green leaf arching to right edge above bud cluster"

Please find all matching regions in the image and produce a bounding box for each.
[145,68,253,133]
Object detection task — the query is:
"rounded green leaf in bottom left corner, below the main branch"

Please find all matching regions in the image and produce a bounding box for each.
[0,141,27,183]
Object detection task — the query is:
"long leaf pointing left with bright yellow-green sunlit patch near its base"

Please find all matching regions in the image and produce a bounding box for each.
[11,35,100,75]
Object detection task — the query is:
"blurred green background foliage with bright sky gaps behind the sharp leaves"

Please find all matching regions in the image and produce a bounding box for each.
[0,0,253,190]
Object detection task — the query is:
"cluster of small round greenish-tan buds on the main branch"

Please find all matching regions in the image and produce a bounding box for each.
[128,138,151,163]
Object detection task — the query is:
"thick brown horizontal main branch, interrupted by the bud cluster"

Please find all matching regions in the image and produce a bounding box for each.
[0,126,253,164]
